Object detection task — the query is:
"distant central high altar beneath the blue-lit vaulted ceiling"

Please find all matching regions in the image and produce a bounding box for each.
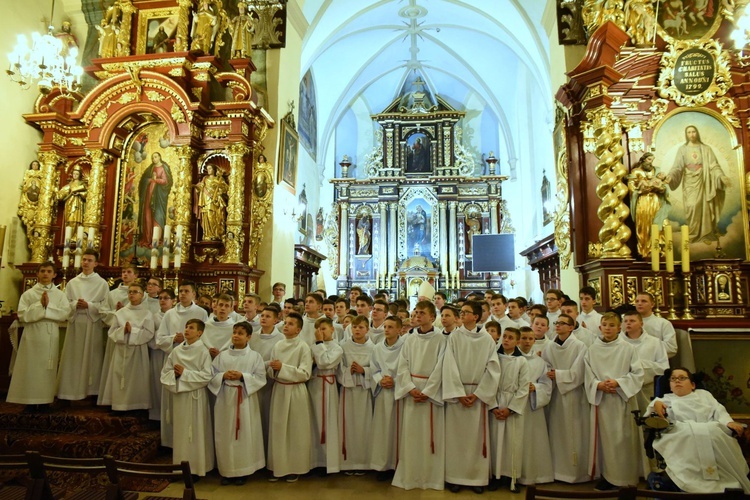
[331,79,513,297]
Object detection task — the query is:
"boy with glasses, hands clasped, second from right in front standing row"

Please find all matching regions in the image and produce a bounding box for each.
[542,314,590,483]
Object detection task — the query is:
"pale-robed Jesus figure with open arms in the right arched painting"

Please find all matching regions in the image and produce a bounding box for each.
[659,125,731,244]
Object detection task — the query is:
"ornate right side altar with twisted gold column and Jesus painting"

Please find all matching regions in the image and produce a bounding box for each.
[556,0,750,320]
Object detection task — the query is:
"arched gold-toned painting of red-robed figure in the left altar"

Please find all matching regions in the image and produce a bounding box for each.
[113,123,178,266]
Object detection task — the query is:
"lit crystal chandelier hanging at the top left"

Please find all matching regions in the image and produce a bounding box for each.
[6,0,83,94]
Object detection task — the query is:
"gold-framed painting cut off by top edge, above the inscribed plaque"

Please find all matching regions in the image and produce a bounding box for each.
[658,0,723,40]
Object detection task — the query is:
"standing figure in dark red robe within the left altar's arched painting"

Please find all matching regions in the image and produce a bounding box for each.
[138,153,172,248]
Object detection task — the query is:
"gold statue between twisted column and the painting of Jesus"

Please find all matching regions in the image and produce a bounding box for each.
[628,153,671,257]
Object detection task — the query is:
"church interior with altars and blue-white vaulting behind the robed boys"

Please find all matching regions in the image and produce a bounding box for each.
[0,0,750,498]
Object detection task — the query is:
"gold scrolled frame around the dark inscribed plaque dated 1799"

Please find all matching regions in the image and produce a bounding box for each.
[657,40,732,107]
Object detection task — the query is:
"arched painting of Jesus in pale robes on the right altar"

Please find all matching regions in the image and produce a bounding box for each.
[653,108,748,260]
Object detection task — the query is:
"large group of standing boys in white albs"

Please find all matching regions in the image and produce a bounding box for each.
[8,258,736,493]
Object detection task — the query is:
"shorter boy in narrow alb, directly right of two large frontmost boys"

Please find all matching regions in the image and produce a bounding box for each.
[489,327,531,493]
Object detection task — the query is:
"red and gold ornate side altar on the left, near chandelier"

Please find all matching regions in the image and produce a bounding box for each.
[19,0,274,295]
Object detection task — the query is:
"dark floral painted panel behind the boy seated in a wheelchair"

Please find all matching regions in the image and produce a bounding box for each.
[690,331,750,418]
